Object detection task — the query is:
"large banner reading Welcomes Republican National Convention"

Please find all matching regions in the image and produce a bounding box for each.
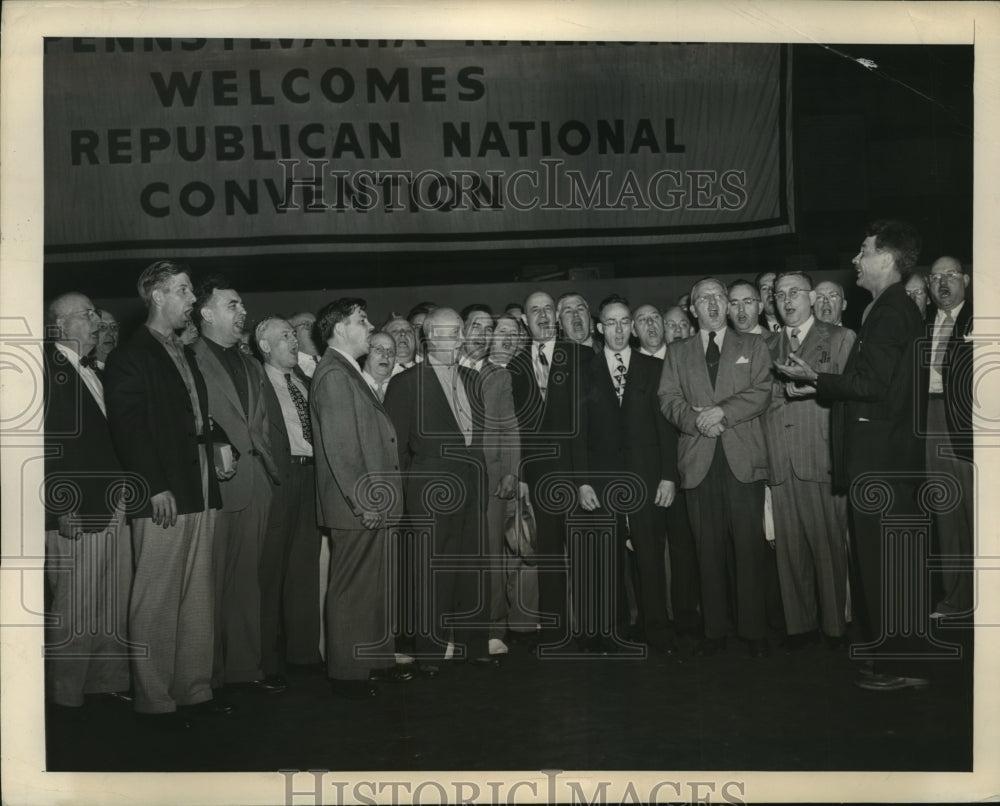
[44,38,793,261]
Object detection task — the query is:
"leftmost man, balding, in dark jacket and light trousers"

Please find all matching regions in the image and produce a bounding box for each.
[43,293,132,708]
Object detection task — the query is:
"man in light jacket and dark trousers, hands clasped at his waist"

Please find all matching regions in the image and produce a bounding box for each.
[659,278,771,657]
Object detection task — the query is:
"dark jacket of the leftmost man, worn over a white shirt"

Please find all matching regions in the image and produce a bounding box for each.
[42,342,125,532]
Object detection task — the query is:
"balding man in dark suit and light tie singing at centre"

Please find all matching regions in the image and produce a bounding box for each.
[507,291,596,651]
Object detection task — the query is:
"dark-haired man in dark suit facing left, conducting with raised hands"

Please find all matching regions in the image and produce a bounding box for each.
[776,220,928,691]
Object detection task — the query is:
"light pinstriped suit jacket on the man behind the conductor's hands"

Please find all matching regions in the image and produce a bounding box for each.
[764,317,855,484]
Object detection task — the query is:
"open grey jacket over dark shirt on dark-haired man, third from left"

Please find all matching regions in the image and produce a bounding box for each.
[192,338,279,512]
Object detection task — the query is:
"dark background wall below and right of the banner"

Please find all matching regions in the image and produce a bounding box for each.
[45,45,973,332]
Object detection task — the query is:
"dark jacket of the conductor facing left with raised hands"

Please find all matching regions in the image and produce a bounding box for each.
[816,283,928,489]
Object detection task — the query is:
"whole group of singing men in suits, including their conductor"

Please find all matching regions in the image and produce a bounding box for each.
[45,221,973,728]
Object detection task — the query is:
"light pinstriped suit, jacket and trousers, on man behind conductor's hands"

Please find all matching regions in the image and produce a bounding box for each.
[764,318,855,636]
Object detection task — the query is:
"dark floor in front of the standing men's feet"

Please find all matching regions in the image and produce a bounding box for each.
[47,629,973,772]
